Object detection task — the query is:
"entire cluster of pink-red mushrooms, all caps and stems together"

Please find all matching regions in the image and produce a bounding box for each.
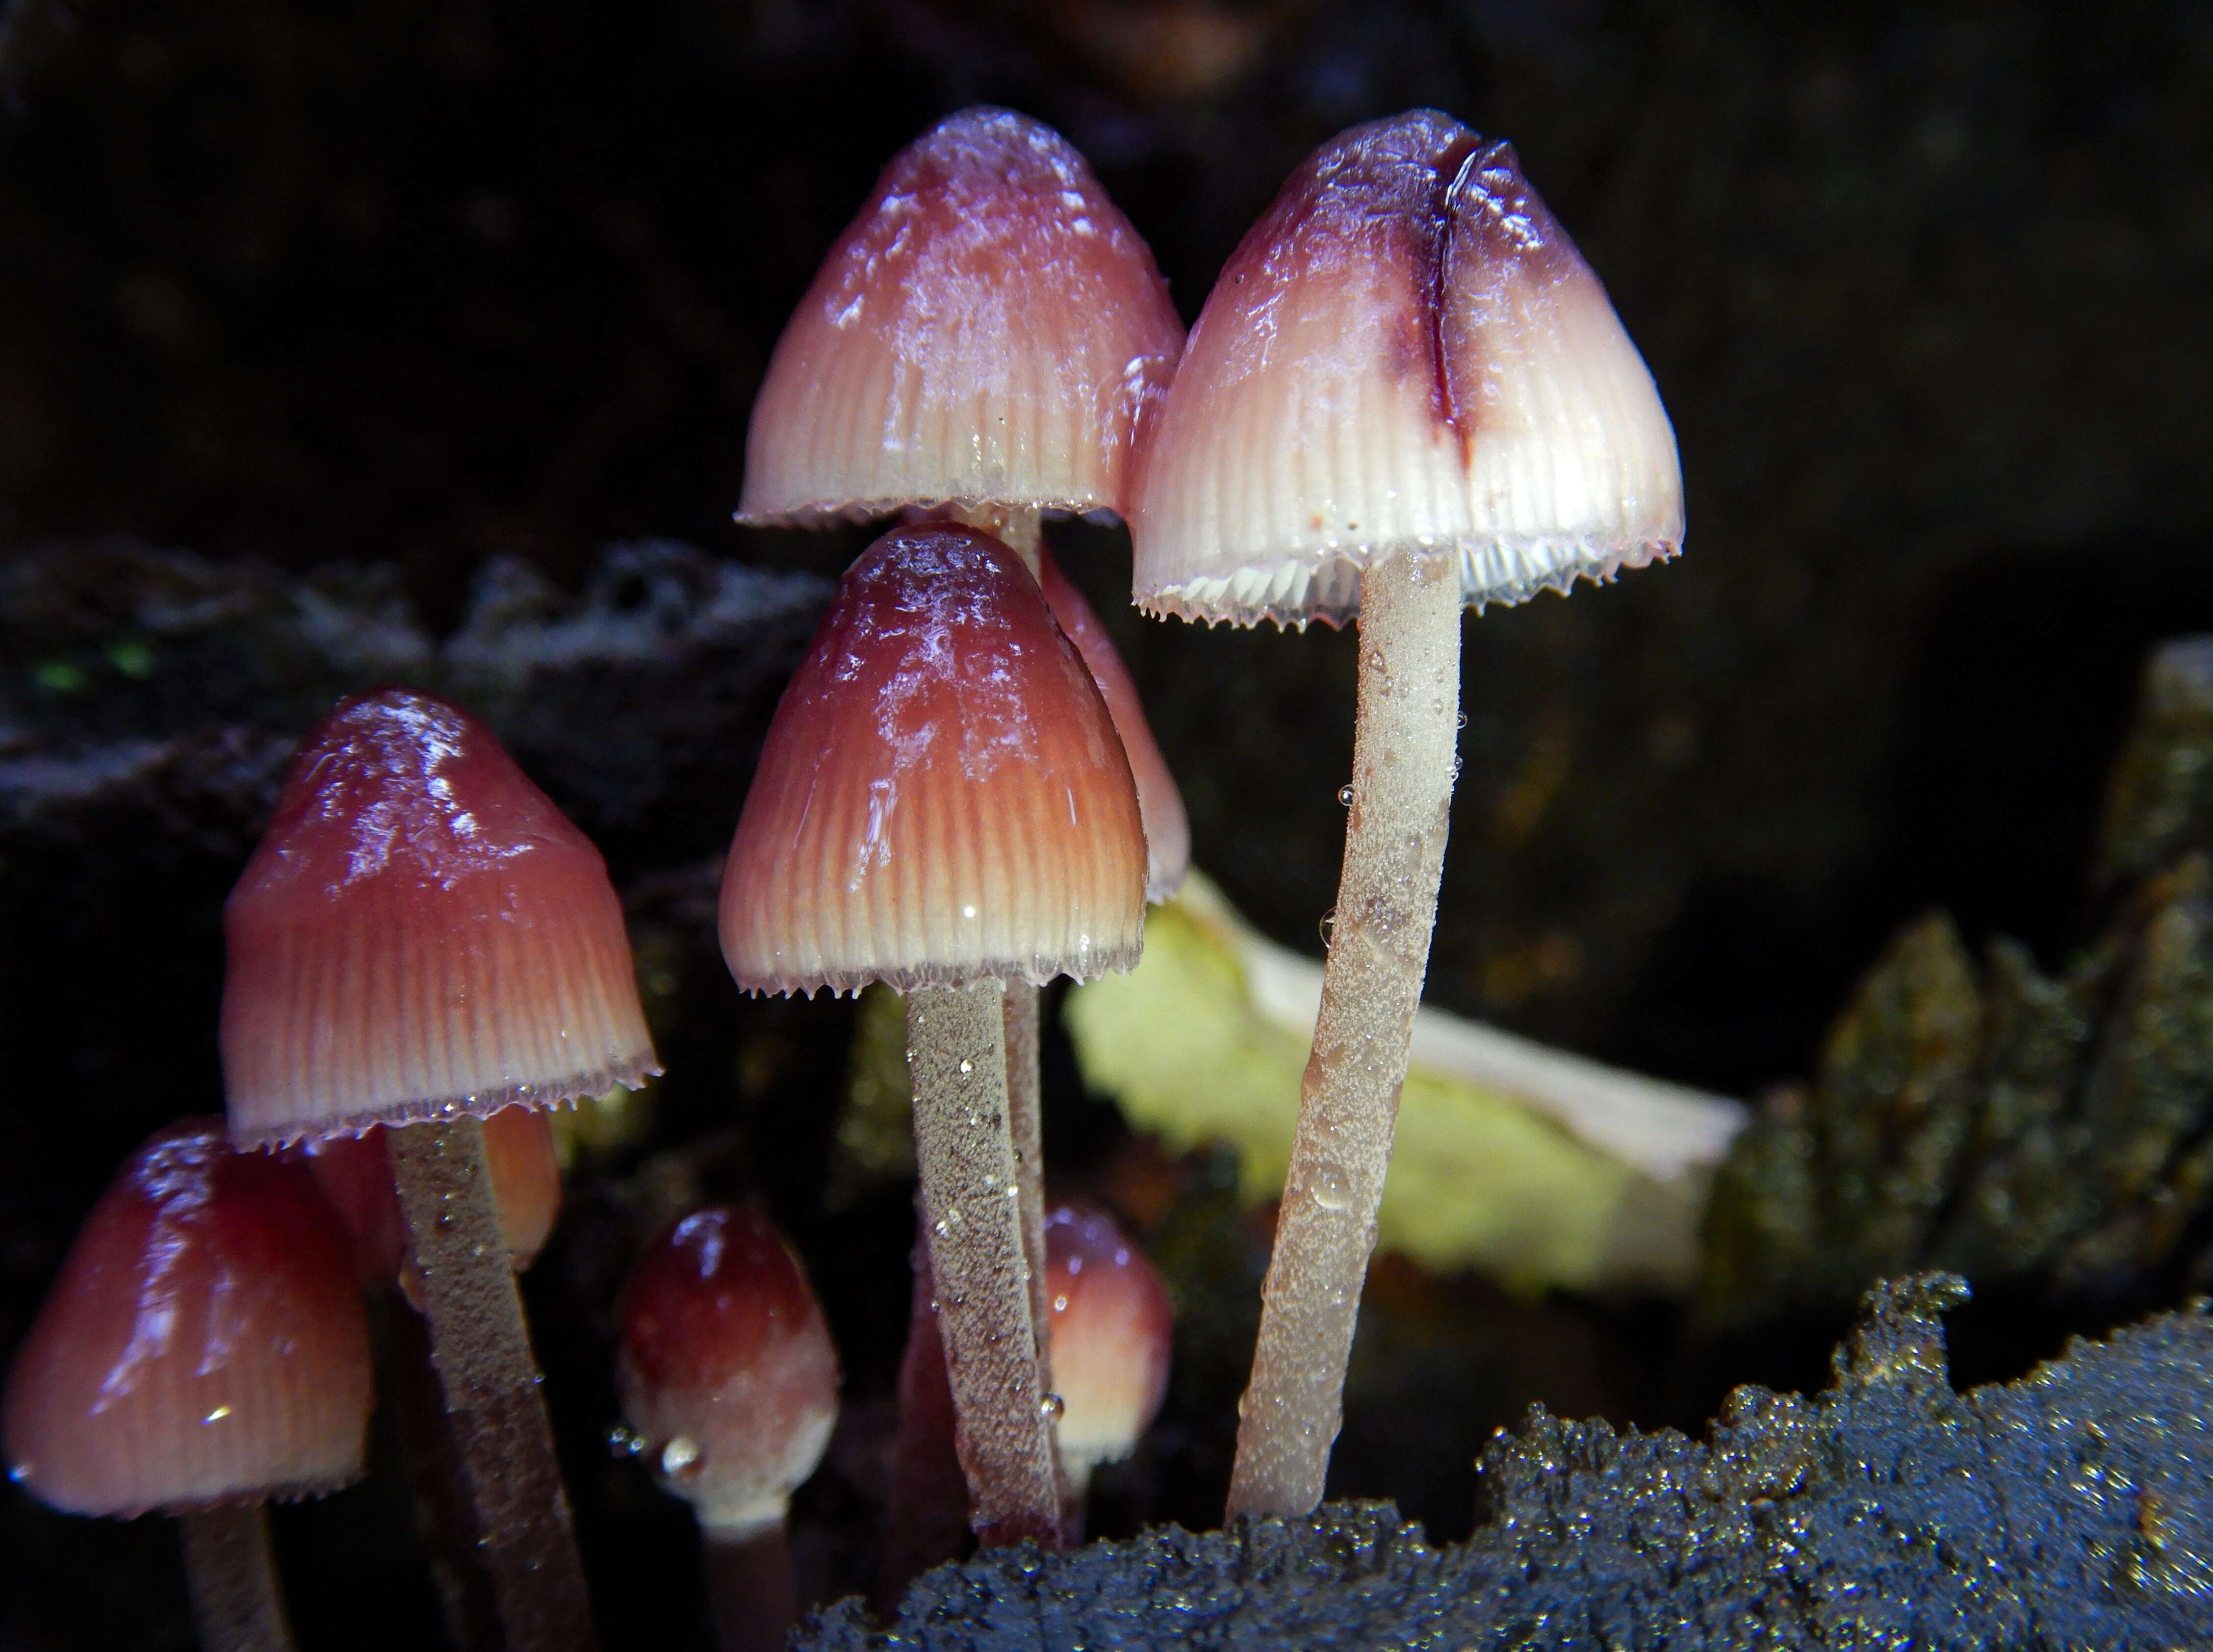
[4,108,1682,1652]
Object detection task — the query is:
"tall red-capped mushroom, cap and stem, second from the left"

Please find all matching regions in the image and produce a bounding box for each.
[224,689,660,1652]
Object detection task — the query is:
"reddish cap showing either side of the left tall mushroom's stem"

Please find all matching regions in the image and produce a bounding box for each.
[308,1107,560,1300]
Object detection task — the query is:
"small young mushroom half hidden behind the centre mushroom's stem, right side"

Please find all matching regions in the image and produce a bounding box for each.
[1045,1205,1175,1530]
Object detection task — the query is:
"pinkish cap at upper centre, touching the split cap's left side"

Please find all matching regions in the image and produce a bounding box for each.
[739,108,1184,520]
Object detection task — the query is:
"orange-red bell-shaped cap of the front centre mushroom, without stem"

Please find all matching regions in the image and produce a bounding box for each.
[721,522,1144,992]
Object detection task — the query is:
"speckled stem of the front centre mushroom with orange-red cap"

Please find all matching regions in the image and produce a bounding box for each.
[907,981,1060,1548]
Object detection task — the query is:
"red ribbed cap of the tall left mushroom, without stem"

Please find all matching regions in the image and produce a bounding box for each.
[224,689,660,1143]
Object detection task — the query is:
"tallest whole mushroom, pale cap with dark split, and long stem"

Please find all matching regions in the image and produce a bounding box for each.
[1131,111,1682,1515]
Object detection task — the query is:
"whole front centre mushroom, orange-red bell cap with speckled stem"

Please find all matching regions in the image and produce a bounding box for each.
[721,522,1144,1544]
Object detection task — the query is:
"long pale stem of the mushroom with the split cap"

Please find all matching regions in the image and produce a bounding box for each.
[1228,554,1461,1519]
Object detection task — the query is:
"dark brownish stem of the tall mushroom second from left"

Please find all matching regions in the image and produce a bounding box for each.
[389,1116,597,1652]
